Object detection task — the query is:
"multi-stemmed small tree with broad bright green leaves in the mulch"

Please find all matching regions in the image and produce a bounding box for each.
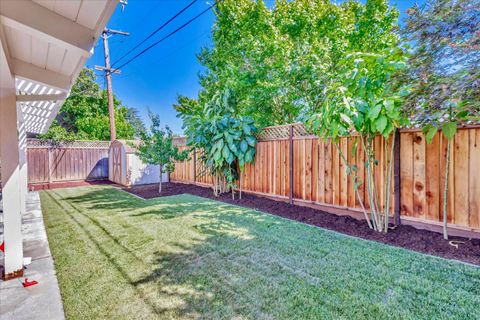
[306,48,408,232]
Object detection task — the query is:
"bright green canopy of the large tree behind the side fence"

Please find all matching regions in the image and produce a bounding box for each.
[177,0,398,127]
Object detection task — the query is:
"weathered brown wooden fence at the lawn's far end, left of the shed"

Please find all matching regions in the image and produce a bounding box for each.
[27,139,110,185]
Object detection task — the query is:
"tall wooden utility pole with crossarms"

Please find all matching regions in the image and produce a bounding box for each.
[95,28,130,141]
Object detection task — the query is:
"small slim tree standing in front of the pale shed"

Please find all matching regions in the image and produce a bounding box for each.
[135,111,188,193]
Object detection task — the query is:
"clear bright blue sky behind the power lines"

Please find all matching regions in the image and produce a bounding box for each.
[87,0,421,133]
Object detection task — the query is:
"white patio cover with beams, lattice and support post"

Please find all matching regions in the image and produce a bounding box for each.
[0,0,118,279]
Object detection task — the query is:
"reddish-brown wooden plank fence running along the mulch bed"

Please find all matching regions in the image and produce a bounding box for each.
[171,124,480,231]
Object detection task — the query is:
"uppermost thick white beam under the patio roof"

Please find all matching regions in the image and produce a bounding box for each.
[0,1,95,57]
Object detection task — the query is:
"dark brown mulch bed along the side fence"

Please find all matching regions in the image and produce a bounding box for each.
[124,183,480,265]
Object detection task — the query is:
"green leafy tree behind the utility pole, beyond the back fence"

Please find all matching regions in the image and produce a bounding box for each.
[40,68,143,140]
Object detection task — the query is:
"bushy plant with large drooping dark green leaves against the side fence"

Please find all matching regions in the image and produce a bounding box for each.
[176,90,257,197]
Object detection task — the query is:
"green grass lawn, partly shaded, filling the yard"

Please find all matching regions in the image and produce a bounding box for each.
[40,186,480,319]
